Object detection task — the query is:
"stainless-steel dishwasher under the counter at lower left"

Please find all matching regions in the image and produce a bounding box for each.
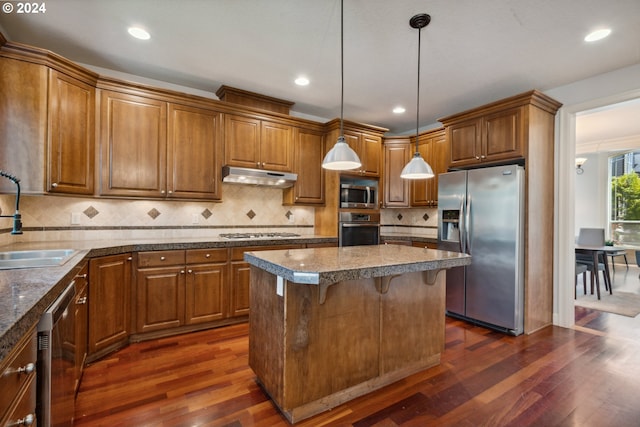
[36,282,76,427]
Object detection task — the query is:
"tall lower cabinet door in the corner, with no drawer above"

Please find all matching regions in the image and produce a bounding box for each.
[89,254,131,354]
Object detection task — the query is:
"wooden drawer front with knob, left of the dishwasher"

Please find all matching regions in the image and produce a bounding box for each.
[0,330,38,415]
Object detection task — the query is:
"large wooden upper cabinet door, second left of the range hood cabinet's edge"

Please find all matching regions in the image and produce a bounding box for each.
[167,104,222,200]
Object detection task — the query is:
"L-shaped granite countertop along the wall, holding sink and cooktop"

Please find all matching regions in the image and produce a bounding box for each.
[0,235,338,360]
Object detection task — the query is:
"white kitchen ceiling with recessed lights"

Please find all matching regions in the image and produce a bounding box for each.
[0,0,640,140]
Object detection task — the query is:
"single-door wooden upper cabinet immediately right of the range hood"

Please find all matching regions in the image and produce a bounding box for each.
[282,128,325,205]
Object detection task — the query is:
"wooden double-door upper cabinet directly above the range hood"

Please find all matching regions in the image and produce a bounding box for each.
[225,114,293,172]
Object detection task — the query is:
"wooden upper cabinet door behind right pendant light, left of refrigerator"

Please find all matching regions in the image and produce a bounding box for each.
[411,128,451,206]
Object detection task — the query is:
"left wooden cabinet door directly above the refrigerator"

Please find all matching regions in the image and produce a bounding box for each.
[447,119,482,167]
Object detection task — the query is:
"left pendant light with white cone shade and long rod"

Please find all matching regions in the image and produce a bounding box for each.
[322,0,362,170]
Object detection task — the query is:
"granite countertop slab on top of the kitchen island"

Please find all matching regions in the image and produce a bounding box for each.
[244,245,471,285]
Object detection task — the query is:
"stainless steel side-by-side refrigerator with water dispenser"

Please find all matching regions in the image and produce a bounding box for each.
[438,165,525,335]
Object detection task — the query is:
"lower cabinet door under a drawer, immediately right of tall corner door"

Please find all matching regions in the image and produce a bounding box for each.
[136,266,185,333]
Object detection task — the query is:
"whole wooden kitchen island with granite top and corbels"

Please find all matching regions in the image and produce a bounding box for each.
[245,245,471,423]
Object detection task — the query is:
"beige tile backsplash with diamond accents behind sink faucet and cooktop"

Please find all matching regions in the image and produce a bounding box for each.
[0,184,315,244]
